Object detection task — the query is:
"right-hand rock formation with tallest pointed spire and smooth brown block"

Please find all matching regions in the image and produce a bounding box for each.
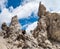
[33,3,60,49]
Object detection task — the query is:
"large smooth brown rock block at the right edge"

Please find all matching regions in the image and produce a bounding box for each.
[47,13,60,41]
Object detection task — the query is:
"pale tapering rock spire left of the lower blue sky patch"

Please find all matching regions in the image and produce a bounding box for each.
[9,16,22,40]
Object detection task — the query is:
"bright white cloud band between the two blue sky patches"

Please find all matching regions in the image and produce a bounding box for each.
[0,2,39,24]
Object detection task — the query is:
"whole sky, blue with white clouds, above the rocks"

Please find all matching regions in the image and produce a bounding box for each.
[0,0,60,30]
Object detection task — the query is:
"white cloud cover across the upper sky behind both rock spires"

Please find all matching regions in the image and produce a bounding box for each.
[0,0,60,30]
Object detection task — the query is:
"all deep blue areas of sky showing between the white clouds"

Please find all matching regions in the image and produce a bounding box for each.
[6,0,38,29]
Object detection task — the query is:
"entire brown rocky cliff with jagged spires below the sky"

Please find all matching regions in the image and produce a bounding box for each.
[0,3,60,49]
